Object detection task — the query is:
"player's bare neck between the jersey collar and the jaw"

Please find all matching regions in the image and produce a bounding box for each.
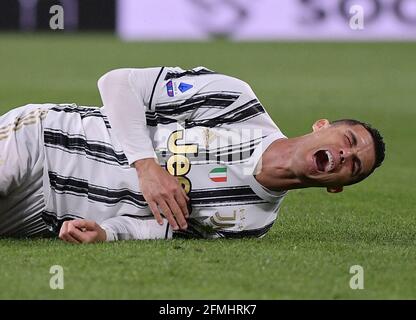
[255,138,304,191]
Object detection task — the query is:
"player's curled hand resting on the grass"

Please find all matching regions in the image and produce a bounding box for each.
[59,219,107,243]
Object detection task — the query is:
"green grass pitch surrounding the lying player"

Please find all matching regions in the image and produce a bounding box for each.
[0,33,416,299]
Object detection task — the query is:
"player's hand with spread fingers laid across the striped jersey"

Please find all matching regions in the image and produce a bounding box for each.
[134,158,189,230]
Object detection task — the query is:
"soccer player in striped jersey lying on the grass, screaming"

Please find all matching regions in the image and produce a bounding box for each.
[0,67,384,243]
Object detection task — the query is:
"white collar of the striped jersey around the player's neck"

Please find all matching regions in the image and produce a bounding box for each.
[244,131,287,202]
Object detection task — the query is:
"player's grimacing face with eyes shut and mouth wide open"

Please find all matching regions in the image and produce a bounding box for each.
[294,119,375,192]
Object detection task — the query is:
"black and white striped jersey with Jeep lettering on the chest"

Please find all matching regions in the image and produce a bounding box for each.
[44,67,285,238]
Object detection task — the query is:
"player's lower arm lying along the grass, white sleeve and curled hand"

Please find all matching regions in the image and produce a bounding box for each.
[59,216,172,244]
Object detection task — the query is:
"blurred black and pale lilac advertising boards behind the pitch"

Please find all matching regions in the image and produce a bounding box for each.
[0,0,416,41]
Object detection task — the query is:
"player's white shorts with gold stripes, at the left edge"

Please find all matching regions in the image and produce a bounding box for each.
[0,104,53,237]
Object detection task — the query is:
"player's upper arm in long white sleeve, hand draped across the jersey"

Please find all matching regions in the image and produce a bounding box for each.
[98,68,189,229]
